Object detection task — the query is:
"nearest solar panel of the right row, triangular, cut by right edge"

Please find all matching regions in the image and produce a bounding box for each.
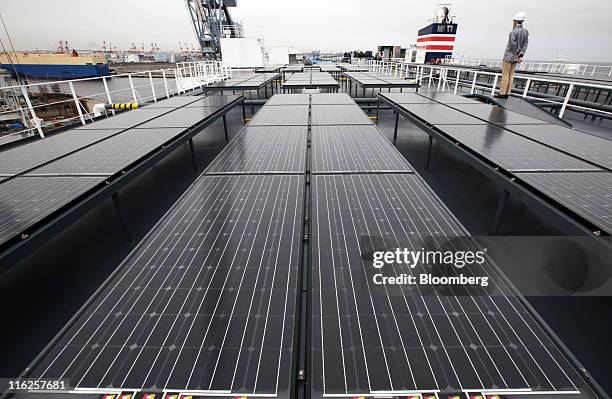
[517,172,612,234]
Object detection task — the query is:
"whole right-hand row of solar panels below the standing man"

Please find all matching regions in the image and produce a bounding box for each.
[380,93,612,234]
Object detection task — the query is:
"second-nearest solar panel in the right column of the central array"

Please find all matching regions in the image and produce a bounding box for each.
[312,125,413,173]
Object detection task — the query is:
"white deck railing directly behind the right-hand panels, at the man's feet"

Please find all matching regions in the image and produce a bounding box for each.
[358,60,612,118]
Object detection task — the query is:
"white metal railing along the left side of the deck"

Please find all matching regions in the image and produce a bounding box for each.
[0,61,231,138]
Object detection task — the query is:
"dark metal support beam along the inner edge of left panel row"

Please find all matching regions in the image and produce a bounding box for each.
[0,97,244,272]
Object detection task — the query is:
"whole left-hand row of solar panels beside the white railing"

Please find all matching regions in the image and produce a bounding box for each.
[0,96,242,252]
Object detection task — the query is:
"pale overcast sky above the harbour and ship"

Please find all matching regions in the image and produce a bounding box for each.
[0,0,612,62]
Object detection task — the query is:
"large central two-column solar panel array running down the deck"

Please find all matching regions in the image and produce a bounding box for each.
[16,95,596,398]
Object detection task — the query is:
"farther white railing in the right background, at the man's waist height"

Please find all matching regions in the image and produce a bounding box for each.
[442,57,612,78]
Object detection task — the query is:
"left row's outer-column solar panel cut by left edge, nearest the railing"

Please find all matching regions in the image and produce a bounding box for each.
[0,129,121,175]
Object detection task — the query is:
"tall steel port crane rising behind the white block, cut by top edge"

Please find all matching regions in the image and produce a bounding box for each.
[185,0,237,58]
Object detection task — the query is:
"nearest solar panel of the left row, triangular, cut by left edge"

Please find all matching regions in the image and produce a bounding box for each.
[0,177,104,244]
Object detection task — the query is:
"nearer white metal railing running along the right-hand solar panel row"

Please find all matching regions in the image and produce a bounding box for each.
[357,60,612,118]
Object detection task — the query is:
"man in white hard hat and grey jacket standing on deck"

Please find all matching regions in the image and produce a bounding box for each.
[495,11,529,98]
